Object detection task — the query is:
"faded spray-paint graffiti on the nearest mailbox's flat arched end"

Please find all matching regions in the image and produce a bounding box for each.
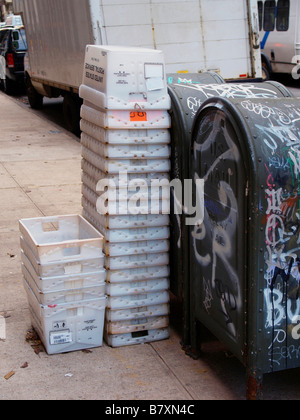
[192,113,242,337]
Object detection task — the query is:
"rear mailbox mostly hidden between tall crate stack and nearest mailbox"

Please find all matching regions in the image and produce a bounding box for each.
[168,77,292,346]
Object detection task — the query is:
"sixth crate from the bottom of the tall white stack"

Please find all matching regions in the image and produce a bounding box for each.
[107,265,170,283]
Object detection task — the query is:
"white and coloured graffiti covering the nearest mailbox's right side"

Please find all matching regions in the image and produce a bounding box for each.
[242,100,300,368]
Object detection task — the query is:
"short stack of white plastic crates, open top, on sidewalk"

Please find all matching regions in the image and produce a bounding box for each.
[19,215,107,354]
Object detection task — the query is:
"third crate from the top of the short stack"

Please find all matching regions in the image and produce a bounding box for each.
[21,253,106,293]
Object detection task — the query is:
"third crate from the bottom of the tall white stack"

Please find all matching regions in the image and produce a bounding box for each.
[105,303,170,322]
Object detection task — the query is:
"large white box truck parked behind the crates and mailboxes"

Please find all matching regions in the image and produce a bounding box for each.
[13,0,262,132]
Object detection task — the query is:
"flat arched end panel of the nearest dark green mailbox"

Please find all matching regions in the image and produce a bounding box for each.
[190,105,248,360]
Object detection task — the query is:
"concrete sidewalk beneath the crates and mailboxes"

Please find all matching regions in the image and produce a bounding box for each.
[0,93,300,401]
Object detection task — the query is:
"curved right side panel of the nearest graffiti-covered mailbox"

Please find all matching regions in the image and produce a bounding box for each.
[233,98,300,379]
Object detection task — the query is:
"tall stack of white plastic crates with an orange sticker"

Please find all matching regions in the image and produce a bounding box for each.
[80,46,170,347]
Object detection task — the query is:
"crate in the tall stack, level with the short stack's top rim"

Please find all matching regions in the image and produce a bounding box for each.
[82,201,170,229]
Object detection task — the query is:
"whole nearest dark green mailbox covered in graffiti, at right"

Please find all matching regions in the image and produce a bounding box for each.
[190,98,300,399]
